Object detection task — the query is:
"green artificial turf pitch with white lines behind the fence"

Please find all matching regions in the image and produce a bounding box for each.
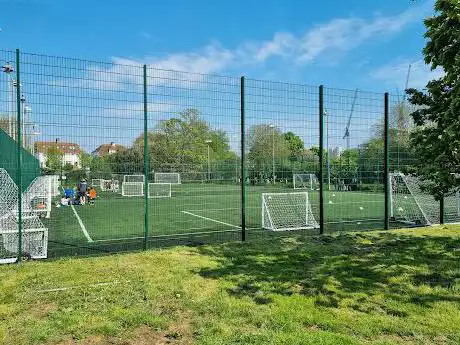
[44,184,392,255]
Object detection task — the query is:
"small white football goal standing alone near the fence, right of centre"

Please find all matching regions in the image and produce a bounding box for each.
[262,192,319,231]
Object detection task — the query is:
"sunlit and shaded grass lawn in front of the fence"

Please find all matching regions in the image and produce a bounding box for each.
[0,224,460,345]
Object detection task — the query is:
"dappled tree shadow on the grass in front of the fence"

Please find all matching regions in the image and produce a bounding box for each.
[198,231,460,310]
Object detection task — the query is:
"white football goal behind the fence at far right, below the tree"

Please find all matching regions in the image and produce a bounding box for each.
[390,172,460,225]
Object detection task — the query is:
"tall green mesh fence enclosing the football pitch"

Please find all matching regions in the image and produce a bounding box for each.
[0,51,460,259]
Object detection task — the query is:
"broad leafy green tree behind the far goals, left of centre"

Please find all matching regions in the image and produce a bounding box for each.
[125,109,237,180]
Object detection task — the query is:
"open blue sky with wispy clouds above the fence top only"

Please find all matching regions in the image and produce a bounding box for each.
[0,0,442,91]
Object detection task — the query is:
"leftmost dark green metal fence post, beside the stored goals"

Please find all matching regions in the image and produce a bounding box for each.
[16,49,22,263]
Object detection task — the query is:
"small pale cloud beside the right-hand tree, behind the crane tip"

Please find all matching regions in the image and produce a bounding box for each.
[371,60,444,90]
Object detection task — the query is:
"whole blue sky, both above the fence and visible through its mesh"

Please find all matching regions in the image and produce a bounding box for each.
[0,0,441,150]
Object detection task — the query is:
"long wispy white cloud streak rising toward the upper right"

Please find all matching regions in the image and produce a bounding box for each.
[54,1,432,90]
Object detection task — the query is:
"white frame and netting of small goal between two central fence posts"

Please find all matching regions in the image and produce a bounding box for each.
[262,192,319,231]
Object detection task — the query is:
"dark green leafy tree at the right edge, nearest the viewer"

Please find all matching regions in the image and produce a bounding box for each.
[407,0,460,199]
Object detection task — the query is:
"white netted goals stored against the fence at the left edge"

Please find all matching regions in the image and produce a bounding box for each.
[0,169,48,263]
